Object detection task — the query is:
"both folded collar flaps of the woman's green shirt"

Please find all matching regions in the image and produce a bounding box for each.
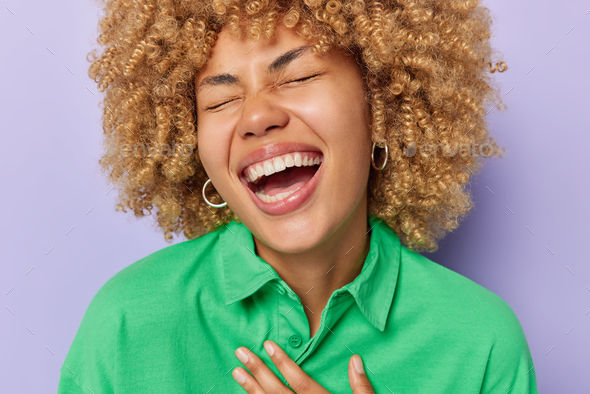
[220,216,401,331]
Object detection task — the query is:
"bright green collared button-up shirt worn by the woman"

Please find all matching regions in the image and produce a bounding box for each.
[58,217,537,394]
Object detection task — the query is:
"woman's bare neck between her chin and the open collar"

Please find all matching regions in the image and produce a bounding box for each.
[254,197,370,336]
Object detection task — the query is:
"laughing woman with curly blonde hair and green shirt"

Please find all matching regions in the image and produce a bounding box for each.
[58,0,537,394]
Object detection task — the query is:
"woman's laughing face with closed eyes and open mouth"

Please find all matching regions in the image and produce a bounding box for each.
[195,25,372,253]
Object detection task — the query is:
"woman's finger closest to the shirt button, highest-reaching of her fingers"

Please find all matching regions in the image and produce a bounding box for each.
[264,340,328,394]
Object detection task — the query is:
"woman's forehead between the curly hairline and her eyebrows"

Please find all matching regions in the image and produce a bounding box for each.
[196,23,312,84]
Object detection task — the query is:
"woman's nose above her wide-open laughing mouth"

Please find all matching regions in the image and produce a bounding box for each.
[237,94,289,138]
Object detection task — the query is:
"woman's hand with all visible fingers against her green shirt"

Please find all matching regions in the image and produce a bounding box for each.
[232,341,375,394]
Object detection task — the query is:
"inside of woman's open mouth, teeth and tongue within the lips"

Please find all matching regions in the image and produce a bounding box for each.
[242,152,324,203]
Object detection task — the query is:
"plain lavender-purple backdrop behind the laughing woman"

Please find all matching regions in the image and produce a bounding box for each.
[0,0,590,393]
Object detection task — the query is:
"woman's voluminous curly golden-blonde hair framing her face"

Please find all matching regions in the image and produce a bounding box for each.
[88,0,507,252]
